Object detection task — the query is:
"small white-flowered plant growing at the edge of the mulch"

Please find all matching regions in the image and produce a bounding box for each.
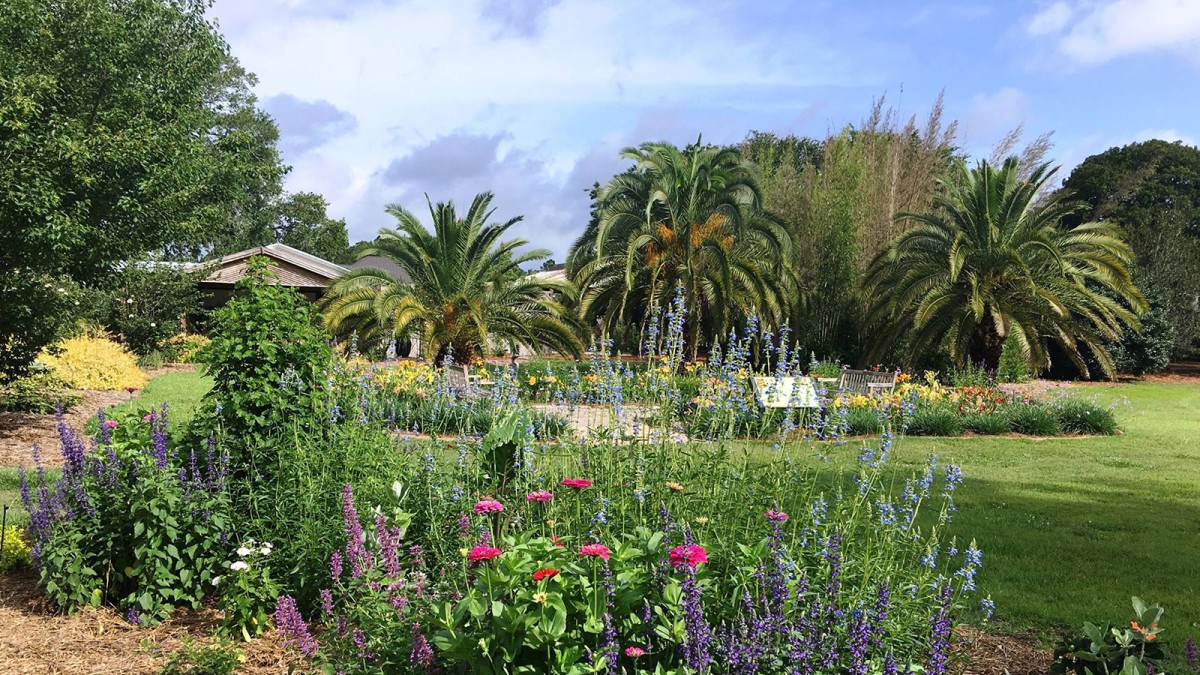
[212,539,280,641]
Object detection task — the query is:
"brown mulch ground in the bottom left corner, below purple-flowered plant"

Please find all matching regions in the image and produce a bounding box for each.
[0,573,289,675]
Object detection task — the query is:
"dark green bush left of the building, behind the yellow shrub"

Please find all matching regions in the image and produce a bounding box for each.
[91,261,208,357]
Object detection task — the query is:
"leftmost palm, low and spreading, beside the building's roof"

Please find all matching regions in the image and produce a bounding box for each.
[322,192,582,364]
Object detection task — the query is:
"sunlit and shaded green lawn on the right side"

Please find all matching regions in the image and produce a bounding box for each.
[801,383,1200,645]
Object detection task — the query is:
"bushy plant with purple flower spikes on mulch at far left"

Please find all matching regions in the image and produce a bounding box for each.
[20,403,229,622]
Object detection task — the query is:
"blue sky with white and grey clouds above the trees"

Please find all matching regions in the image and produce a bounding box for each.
[211,0,1200,261]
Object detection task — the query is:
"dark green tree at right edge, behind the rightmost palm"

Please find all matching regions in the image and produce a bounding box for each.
[1063,141,1200,357]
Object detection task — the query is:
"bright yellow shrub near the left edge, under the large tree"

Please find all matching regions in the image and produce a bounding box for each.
[38,334,149,390]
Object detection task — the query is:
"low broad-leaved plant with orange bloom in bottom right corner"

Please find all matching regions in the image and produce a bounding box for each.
[1050,596,1164,675]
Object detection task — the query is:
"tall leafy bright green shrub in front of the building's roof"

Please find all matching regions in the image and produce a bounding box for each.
[197,257,331,451]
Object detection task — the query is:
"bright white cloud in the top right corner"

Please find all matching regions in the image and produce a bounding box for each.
[1025,0,1200,65]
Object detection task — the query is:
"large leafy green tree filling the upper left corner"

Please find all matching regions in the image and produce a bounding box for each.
[0,0,283,374]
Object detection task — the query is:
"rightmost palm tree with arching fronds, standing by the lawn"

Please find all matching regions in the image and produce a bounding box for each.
[864,157,1146,376]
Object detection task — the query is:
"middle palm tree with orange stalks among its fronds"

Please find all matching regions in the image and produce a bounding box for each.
[568,139,791,358]
